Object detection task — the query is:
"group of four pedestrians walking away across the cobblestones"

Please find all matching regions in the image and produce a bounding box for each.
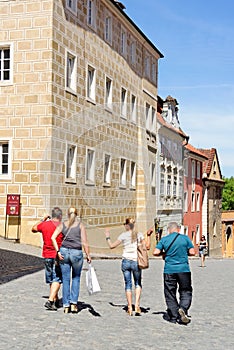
[32,207,195,325]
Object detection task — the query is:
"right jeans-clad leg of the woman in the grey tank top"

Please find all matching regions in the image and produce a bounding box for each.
[70,249,83,305]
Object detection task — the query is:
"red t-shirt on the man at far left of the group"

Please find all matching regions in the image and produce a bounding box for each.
[37,220,63,258]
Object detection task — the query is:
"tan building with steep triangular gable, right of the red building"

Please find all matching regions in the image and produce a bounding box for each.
[199,148,224,256]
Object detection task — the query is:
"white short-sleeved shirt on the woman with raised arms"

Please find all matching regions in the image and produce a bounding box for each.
[118,231,144,261]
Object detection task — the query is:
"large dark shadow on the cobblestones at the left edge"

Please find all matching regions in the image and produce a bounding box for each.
[0,249,44,284]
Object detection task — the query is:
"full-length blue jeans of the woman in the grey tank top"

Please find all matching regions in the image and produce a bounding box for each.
[60,247,83,307]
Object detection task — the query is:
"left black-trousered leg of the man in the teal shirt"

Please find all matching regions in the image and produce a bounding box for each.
[163,273,179,322]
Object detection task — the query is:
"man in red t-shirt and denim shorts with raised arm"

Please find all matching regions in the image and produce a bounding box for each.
[32,207,63,311]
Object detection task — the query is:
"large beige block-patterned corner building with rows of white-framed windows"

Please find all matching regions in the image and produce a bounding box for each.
[0,0,163,252]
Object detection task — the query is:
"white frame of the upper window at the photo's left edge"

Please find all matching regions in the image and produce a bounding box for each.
[0,42,14,86]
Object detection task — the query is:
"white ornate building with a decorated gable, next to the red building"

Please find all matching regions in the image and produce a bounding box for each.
[156,96,189,238]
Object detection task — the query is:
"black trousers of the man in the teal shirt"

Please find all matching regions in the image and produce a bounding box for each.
[164,272,193,320]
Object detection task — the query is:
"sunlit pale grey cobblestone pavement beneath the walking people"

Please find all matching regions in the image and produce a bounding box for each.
[0,239,234,350]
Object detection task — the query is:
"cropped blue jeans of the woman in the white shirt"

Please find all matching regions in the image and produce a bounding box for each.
[121,259,142,291]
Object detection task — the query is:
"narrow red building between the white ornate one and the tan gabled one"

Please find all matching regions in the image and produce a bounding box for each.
[183,144,208,252]
